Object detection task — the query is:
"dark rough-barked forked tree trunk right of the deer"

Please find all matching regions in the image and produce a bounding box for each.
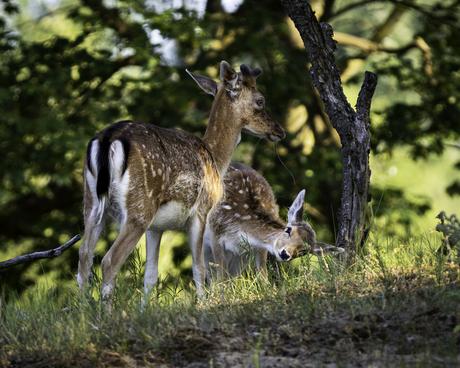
[282,0,377,252]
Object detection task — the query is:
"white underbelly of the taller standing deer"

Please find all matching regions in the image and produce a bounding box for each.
[149,202,193,230]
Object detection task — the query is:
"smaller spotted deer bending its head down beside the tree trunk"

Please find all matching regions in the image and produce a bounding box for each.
[204,164,344,280]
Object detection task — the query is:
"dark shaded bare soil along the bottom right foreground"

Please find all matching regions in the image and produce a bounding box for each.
[153,308,460,368]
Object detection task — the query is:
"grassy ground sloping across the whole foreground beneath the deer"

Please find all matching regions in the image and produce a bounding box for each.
[0,234,460,367]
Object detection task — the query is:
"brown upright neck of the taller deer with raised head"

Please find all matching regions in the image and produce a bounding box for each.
[203,88,243,176]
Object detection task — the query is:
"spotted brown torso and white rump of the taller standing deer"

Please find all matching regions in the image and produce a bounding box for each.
[85,121,222,229]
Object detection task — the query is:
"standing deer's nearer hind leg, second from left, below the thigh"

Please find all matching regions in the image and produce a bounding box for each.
[102,219,146,310]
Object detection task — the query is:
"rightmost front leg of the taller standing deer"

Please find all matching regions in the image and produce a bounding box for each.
[188,216,206,299]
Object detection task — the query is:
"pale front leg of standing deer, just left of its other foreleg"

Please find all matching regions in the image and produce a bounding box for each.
[142,230,163,306]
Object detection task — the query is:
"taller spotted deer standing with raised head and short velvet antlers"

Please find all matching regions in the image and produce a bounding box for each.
[77,61,285,309]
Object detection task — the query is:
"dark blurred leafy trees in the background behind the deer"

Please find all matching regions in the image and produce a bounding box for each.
[0,0,460,290]
